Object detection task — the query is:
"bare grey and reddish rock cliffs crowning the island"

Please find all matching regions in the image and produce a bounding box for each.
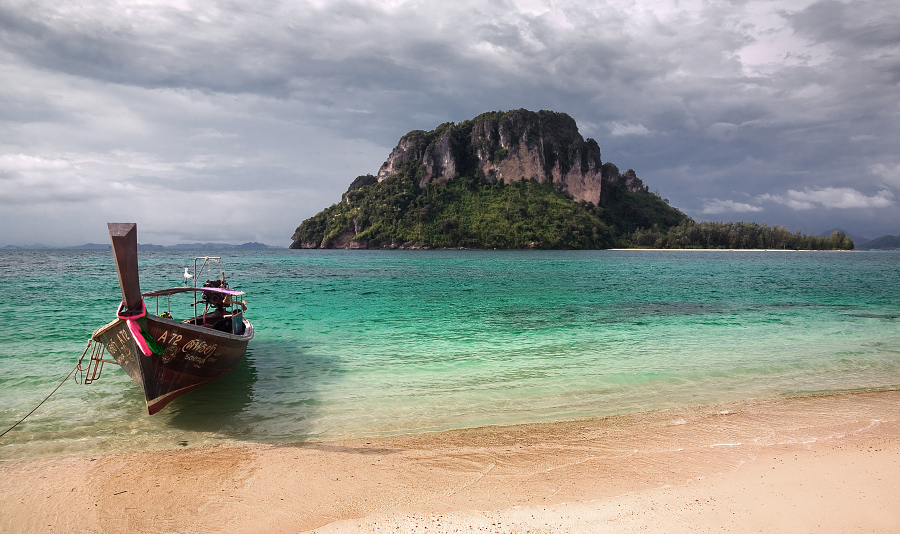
[378,109,643,205]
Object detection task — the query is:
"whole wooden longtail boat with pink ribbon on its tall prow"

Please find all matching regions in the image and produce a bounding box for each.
[82,223,253,415]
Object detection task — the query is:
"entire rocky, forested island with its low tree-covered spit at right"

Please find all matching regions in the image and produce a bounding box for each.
[291,110,853,250]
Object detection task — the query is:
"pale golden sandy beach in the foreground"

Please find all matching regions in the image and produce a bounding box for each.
[0,390,900,534]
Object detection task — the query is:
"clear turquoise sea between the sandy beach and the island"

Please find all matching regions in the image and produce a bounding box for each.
[0,249,900,458]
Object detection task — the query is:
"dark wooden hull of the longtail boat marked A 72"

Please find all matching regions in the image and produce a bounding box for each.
[93,315,253,415]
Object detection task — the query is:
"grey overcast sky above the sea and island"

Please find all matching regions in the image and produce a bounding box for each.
[0,0,900,246]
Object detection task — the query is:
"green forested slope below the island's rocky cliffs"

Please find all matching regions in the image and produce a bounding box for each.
[294,173,652,249]
